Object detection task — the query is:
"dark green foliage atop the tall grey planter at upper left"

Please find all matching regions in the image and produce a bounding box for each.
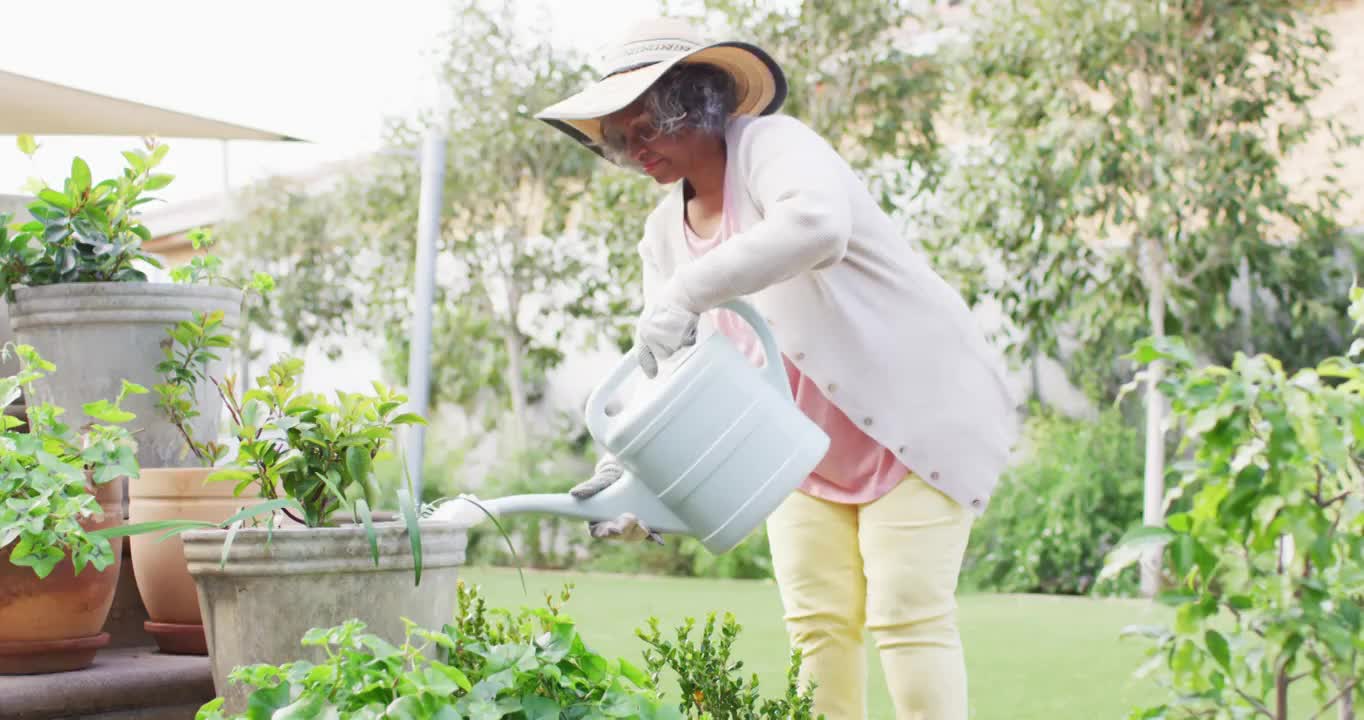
[0,136,173,300]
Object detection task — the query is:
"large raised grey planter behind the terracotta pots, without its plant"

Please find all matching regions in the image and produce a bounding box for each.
[10,282,241,468]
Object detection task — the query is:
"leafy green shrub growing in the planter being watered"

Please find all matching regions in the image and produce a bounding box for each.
[209,357,426,528]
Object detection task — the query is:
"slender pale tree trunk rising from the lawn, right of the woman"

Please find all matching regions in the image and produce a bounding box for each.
[1140,239,1165,597]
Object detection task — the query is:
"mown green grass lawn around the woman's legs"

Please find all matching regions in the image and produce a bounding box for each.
[464,567,1161,720]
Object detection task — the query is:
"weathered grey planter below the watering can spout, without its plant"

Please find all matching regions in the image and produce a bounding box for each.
[181,522,468,712]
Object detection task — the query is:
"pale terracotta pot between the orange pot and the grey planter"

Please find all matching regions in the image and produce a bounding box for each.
[128,468,258,655]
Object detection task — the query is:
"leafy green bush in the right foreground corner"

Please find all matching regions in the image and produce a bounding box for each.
[1106,289,1364,720]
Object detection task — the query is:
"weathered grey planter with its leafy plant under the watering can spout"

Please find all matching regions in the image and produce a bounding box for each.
[165,357,465,709]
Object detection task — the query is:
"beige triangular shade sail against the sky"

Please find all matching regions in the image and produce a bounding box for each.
[0,70,299,140]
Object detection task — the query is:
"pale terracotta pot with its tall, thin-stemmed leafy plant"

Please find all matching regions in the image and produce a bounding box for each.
[128,229,274,655]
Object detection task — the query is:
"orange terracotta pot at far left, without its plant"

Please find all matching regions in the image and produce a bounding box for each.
[0,481,123,675]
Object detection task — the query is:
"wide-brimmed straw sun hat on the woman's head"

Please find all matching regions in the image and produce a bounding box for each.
[536,18,786,154]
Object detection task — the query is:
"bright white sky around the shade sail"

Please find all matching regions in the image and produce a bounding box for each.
[0,0,679,208]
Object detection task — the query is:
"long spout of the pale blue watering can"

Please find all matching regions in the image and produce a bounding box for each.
[436,472,689,535]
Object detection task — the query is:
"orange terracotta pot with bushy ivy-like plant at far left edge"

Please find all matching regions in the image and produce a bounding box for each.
[0,345,146,674]
